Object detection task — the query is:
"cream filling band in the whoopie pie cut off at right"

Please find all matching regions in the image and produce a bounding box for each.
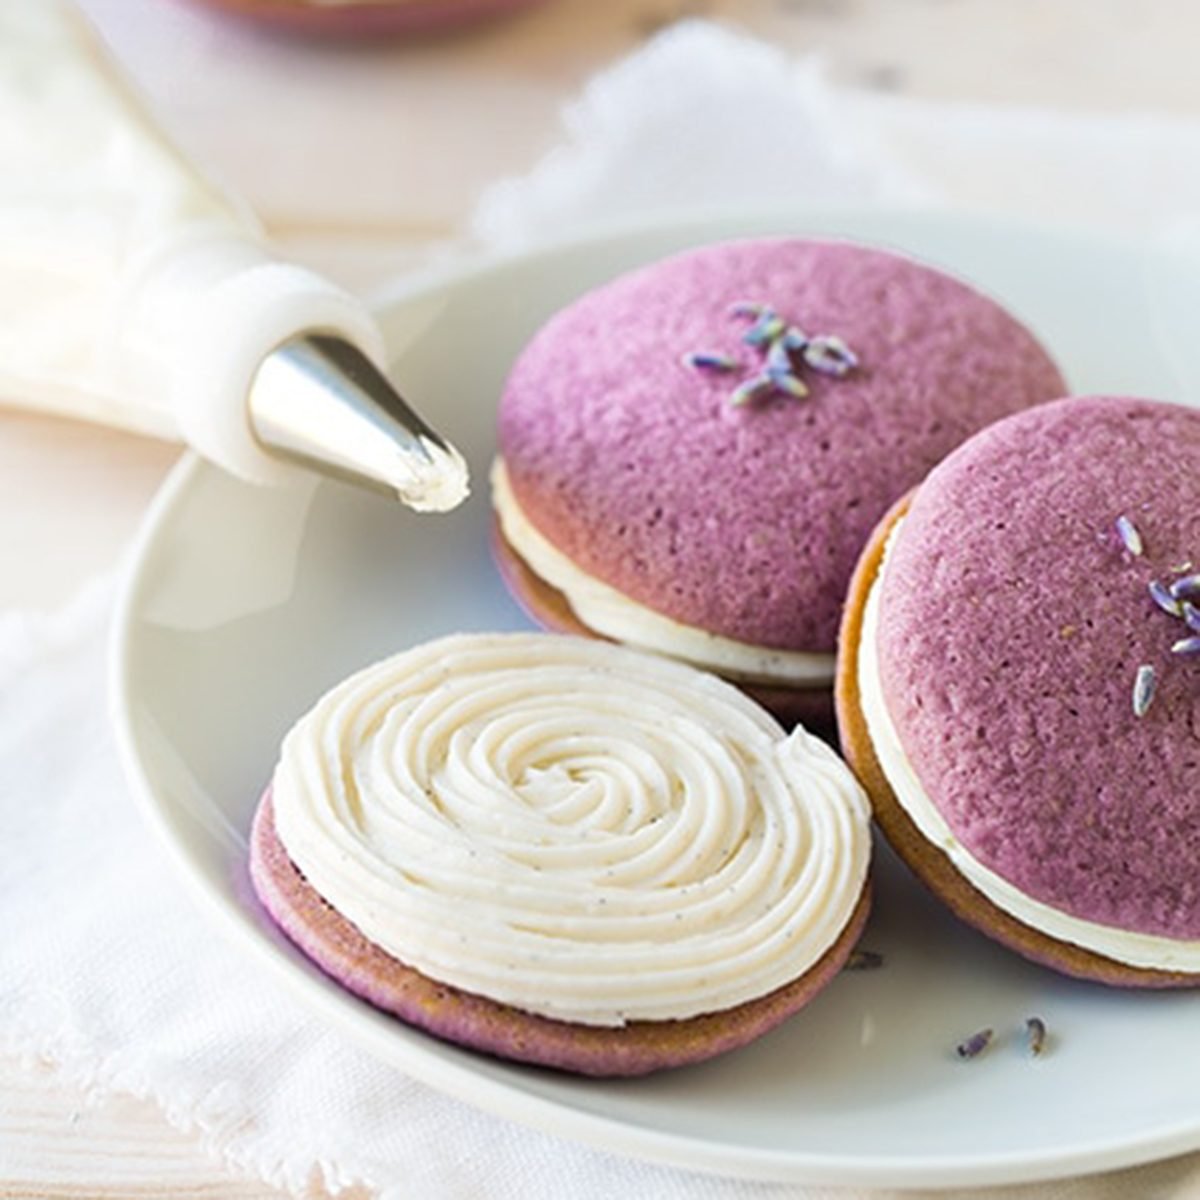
[858,521,1200,972]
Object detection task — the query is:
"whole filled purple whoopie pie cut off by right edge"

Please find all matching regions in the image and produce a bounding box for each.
[838,396,1200,988]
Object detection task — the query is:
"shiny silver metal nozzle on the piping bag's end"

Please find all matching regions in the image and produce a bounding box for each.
[247,334,467,512]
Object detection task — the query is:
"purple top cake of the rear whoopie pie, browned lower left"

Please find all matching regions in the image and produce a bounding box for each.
[499,240,1066,652]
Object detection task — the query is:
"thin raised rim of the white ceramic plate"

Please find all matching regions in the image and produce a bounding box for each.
[108,205,1200,1187]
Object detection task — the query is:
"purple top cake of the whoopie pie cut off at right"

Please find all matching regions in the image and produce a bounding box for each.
[878,397,1200,938]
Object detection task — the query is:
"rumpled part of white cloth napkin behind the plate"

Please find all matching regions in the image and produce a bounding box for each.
[474,22,1200,245]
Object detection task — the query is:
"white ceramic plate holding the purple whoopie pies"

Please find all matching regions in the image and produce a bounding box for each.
[114,214,1200,1186]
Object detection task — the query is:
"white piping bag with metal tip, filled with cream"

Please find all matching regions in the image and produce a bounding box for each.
[0,0,467,511]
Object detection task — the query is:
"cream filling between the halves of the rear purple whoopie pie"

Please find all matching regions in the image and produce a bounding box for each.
[492,458,835,689]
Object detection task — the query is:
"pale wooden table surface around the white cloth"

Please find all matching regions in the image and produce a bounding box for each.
[7,0,1200,1200]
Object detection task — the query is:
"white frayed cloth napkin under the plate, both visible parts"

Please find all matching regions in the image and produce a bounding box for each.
[7,18,1200,1200]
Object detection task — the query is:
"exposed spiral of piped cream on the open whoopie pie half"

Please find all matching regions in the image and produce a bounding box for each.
[272,634,870,1026]
